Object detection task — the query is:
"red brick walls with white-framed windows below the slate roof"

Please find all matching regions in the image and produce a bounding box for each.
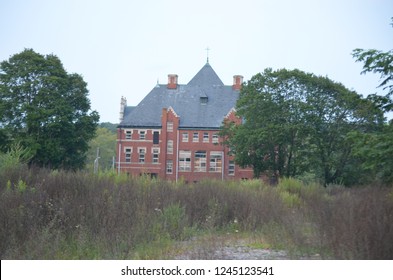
[116,108,253,182]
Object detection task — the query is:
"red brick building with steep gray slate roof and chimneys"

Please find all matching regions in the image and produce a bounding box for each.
[116,63,253,182]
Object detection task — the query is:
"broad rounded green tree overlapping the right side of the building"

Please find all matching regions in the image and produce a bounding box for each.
[222,69,383,184]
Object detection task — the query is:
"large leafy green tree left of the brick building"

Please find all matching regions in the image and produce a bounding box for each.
[0,49,99,169]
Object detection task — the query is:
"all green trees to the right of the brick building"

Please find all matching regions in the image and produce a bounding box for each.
[222,18,393,186]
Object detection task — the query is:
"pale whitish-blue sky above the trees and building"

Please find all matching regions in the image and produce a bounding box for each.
[0,0,393,123]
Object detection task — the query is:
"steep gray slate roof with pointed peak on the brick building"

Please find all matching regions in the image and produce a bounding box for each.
[119,63,239,129]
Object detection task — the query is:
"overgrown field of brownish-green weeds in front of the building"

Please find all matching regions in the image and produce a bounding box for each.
[0,166,393,259]
